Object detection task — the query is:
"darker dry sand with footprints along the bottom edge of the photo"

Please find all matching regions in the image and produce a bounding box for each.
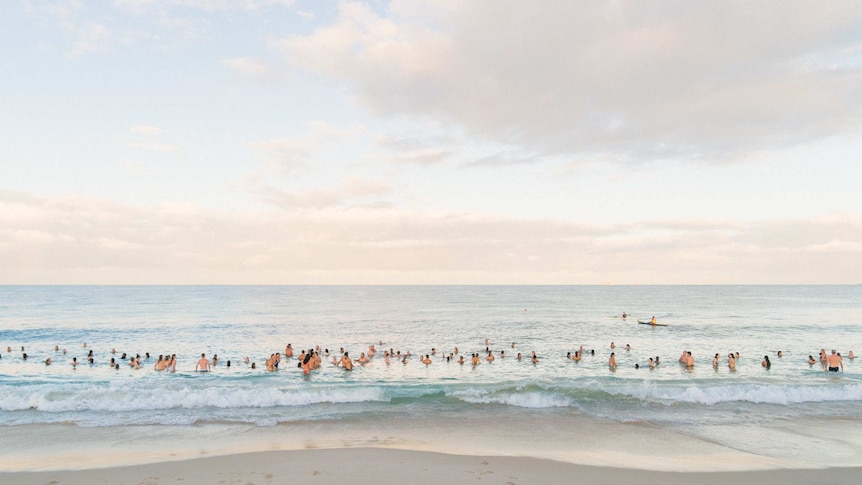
[0,448,862,485]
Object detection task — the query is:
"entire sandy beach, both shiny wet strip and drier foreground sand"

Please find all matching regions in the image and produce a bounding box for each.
[0,410,862,485]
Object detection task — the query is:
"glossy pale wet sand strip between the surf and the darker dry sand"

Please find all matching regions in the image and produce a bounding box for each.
[0,409,862,472]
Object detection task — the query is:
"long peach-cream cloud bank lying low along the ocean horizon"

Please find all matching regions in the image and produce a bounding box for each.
[0,190,862,284]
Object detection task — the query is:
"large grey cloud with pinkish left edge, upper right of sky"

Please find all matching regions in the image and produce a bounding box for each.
[281,0,862,162]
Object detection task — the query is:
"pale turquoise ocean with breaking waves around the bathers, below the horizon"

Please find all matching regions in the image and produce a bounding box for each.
[0,286,862,466]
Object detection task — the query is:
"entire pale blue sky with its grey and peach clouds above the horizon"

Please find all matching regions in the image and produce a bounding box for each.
[0,0,862,284]
